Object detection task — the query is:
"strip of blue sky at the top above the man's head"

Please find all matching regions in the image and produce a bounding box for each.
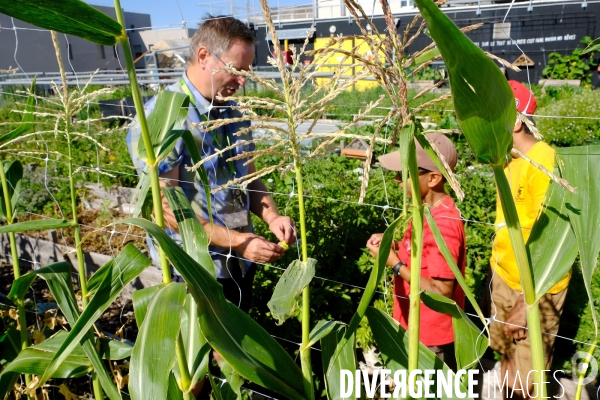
[85,0,311,28]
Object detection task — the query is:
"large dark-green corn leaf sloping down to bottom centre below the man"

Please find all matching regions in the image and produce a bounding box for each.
[119,218,304,399]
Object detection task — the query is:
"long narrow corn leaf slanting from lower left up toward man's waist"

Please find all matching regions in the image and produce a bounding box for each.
[40,243,150,383]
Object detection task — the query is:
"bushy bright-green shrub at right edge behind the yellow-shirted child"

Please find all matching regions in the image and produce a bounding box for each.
[534,89,600,147]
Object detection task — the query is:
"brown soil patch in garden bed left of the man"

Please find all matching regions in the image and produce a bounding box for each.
[19,209,147,256]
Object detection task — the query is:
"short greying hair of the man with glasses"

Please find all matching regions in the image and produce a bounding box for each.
[188,14,256,64]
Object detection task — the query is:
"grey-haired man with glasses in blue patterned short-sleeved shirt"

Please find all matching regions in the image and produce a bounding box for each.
[127,16,296,311]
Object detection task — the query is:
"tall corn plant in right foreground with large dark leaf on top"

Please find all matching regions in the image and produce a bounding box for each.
[416,0,599,396]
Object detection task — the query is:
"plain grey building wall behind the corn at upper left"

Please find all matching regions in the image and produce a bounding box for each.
[0,6,152,73]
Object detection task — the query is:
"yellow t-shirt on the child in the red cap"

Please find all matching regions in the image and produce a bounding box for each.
[490,142,571,294]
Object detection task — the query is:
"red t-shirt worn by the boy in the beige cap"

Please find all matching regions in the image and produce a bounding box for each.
[394,196,467,346]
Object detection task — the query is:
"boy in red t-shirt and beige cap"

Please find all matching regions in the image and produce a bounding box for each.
[367,133,466,370]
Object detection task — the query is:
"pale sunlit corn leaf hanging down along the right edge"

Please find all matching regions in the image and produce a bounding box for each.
[558,145,600,335]
